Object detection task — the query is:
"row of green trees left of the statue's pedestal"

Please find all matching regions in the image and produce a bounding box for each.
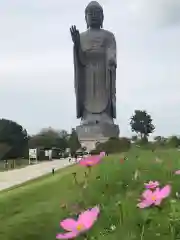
[0,119,81,160]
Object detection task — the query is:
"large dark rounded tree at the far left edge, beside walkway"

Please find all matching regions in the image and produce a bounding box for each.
[0,119,29,158]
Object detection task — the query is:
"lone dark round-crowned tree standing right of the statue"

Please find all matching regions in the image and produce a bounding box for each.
[130,110,155,139]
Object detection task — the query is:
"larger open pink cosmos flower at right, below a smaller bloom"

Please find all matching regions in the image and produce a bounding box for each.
[137,185,171,208]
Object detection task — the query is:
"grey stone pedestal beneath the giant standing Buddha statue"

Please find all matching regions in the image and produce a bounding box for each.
[76,123,119,151]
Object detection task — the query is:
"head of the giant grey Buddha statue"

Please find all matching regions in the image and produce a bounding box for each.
[85,1,104,28]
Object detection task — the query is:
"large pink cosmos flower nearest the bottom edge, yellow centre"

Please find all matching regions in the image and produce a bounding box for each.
[56,206,100,239]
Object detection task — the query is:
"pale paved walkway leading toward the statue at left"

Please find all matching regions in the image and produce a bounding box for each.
[0,159,73,190]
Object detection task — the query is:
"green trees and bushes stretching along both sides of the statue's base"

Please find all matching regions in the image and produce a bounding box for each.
[0,110,180,159]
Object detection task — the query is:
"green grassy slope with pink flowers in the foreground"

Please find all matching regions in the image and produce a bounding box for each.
[0,149,180,240]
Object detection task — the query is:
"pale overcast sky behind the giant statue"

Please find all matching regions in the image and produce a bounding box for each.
[0,0,180,136]
